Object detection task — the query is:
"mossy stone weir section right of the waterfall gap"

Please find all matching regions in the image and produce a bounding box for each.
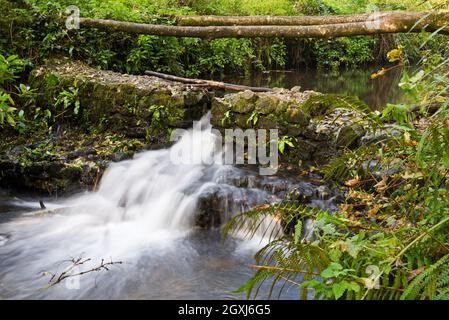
[211,87,365,168]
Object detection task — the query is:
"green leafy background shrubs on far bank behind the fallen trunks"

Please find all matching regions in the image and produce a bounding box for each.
[0,0,424,77]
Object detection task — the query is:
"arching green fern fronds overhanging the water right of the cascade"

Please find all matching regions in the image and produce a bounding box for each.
[222,202,330,299]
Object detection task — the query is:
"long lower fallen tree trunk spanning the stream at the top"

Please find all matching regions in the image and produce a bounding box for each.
[80,11,449,38]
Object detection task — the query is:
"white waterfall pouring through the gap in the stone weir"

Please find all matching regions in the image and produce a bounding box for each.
[85,115,223,233]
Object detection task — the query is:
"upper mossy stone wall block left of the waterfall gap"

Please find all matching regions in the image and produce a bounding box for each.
[31,59,212,138]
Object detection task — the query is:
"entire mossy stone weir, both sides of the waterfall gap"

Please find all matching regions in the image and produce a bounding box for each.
[0,59,361,194]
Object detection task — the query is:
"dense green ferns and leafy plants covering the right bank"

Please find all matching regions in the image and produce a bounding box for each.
[223,35,449,300]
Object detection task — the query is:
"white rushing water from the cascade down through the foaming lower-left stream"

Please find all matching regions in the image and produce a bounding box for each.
[0,116,280,298]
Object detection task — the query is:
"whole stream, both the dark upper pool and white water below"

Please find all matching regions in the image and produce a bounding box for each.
[0,66,406,299]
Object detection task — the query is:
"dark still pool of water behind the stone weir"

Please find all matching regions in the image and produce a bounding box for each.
[222,66,405,110]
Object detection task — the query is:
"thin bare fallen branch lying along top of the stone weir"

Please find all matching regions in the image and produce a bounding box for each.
[145,71,273,92]
